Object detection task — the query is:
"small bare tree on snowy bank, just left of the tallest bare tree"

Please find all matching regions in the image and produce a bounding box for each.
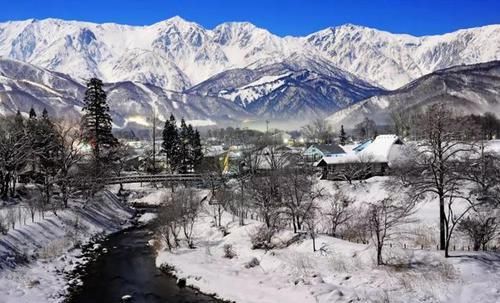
[368,198,415,265]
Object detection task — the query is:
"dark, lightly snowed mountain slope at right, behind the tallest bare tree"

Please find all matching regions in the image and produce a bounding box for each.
[327,61,500,127]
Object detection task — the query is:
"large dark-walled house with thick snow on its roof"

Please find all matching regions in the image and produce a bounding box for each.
[314,135,403,181]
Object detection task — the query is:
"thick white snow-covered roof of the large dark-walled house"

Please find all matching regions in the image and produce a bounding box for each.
[316,135,403,165]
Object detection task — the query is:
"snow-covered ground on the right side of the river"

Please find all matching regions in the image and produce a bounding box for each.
[156,178,500,303]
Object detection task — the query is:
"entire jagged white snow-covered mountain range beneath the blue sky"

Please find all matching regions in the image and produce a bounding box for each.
[0,17,500,90]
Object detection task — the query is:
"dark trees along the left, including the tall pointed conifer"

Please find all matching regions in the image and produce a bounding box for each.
[0,79,120,213]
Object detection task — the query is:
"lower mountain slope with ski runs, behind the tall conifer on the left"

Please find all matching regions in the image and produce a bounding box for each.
[0,59,251,127]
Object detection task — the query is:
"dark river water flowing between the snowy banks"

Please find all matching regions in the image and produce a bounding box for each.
[69,228,220,303]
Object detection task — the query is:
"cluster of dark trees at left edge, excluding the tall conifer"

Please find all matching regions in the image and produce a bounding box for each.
[0,109,82,211]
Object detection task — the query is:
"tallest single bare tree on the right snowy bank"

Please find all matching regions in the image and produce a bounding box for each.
[395,103,474,256]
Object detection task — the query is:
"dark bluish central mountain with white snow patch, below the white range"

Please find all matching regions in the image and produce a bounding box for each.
[188,55,382,120]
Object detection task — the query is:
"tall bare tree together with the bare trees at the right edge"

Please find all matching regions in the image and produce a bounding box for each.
[394,104,500,256]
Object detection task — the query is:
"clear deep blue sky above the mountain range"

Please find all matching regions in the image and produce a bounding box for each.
[0,0,500,36]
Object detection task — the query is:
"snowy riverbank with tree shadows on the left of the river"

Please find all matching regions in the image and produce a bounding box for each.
[0,192,134,303]
